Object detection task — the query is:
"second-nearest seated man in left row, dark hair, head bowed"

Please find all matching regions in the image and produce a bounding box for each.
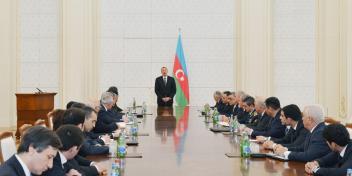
[43,125,84,176]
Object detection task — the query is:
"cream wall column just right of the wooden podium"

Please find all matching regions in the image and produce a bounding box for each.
[60,0,100,105]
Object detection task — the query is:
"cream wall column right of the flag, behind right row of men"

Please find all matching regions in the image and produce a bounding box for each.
[235,0,272,96]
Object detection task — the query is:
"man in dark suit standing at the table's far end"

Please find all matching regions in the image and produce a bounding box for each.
[154,67,176,106]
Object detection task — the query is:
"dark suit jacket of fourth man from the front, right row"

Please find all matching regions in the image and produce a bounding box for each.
[251,111,286,138]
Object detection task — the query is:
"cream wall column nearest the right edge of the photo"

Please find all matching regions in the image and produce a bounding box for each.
[316,0,350,118]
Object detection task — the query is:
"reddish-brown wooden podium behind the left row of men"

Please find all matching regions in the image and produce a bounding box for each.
[16,93,56,137]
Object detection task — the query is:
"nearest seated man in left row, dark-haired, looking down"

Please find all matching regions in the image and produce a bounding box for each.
[0,126,61,176]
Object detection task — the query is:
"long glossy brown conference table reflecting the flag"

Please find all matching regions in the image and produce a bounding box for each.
[88,107,306,176]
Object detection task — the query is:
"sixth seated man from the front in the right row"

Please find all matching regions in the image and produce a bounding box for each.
[237,95,257,124]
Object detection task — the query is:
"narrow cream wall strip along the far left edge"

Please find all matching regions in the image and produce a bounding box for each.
[0,0,17,127]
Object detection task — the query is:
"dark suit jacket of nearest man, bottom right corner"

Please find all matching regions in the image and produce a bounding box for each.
[314,142,352,176]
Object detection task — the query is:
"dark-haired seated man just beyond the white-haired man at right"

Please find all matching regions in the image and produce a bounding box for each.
[261,104,309,150]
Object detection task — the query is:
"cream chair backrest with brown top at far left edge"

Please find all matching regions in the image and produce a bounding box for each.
[0,131,16,163]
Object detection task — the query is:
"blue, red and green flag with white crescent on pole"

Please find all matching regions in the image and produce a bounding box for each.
[173,34,189,106]
